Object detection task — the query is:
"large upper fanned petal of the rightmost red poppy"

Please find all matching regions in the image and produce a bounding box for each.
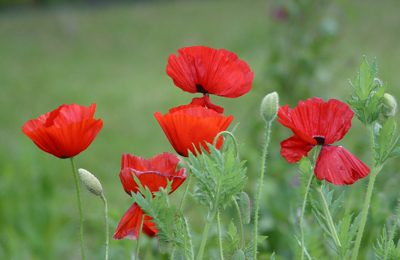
[278,98,354,144]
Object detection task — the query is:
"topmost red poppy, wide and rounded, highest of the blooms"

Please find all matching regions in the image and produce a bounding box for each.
[167,46,254,98]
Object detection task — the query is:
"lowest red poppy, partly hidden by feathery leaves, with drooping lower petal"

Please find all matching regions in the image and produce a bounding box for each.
[114,153,186,239]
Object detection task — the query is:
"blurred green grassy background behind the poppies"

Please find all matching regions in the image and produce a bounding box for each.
[0,0,400,259]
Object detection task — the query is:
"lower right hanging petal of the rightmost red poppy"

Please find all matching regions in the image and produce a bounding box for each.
[314,145,370,185]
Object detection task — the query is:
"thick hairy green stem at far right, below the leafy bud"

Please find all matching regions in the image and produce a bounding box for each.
[351,165,382,260]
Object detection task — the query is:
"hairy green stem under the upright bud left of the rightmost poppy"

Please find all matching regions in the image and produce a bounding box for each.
[253,121,272,259]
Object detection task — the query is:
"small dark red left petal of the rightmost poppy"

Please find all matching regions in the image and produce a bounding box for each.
[281,135,313,163]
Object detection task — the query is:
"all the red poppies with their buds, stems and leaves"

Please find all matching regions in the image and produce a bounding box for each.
[23,46,400,260]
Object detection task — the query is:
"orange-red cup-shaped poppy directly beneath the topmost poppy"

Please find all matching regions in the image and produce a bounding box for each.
[154,99,233,157]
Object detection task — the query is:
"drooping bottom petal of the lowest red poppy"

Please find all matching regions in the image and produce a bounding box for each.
[113,203,158,239]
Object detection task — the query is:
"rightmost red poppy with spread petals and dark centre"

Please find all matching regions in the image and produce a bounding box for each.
[278,98,370,185]
